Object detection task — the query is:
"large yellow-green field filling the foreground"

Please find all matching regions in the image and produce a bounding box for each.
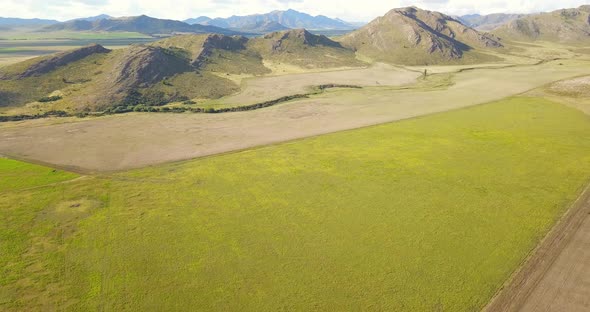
[0,97,590,311]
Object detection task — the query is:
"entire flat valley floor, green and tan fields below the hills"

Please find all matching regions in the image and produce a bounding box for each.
[0,39,590,311]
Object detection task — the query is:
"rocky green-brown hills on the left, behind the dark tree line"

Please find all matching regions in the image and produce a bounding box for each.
[0,30,364,114]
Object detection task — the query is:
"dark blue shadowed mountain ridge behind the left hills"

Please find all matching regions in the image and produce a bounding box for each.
[41,15,245,35]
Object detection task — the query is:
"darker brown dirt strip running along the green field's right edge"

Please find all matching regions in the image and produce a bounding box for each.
[483,182,590,312]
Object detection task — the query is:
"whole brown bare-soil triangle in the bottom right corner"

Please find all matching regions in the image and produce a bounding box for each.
[484,185,590,312]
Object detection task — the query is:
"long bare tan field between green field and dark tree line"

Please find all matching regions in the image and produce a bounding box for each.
[0,61,588,172]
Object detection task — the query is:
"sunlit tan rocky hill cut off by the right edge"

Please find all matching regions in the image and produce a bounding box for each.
[494,5,590,44]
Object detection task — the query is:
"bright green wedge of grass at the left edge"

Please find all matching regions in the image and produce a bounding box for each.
[0,157,77,192]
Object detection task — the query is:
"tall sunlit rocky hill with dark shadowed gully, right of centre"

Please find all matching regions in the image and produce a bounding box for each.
[341,7,503,65]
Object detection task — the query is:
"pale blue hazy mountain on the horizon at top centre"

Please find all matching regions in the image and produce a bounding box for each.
[187,10,355,30]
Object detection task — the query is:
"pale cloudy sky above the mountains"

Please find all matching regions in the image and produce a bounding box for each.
[0,0,590,22]
